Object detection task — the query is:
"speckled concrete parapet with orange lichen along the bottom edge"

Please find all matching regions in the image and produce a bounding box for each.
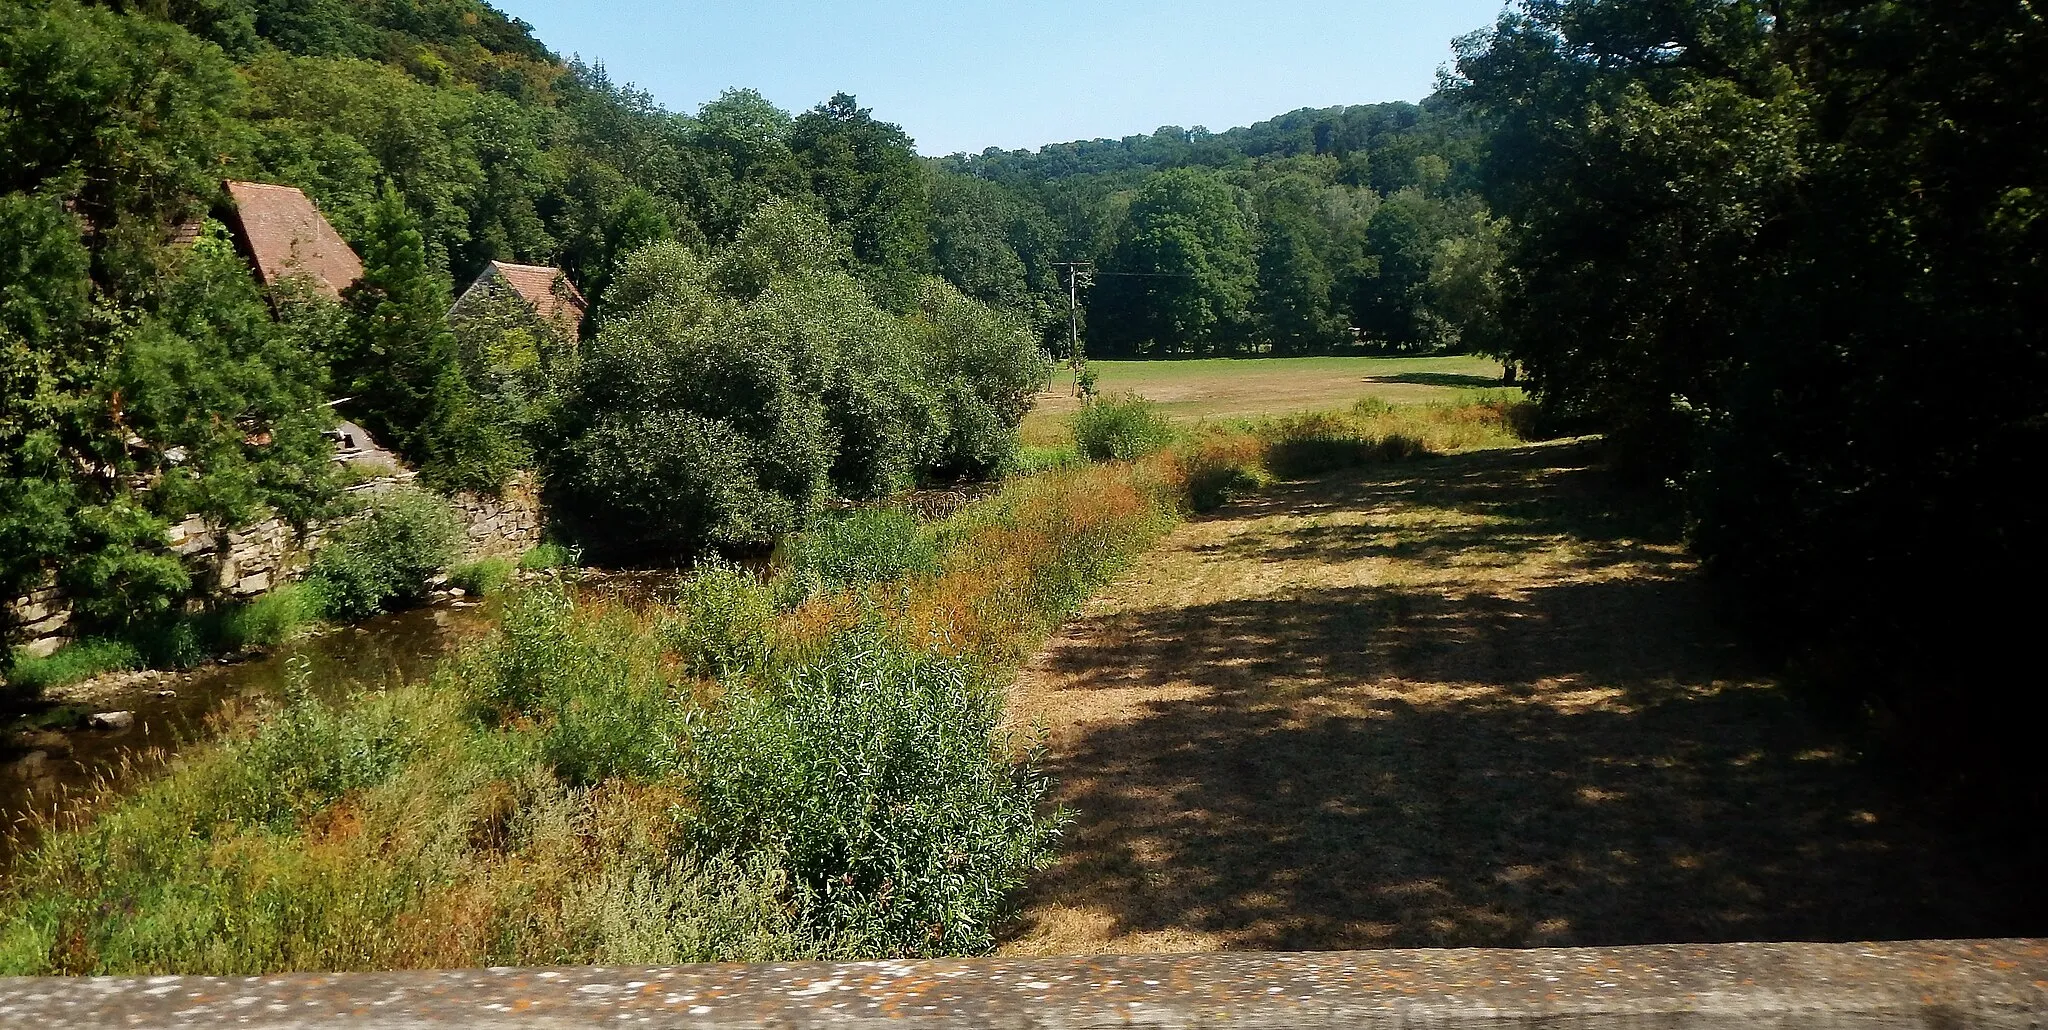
[0,940,2048,1030]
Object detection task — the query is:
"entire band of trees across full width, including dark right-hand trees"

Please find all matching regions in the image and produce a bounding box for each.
[0,0,2048,831]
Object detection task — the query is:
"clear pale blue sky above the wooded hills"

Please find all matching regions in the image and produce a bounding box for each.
[498,0,1503,154]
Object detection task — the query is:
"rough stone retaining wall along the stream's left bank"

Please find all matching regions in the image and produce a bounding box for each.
[0,473,545,655]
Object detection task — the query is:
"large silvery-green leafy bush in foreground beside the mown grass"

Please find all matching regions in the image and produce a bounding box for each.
[688,631,1057,958]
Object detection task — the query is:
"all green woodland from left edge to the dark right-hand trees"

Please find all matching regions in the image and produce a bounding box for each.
[0,0,1499,647]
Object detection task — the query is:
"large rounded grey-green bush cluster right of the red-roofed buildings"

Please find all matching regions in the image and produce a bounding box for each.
[541,226,1047,563]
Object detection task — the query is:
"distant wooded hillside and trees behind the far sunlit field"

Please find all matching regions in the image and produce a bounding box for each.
[934,100,1501,356]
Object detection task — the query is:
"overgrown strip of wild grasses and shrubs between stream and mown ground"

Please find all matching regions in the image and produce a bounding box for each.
[0,399,1520,975]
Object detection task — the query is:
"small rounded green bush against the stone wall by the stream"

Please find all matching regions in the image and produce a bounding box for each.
[307,489,463,620]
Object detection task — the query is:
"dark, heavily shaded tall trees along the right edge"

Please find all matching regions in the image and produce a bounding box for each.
[1458,0,2048,827]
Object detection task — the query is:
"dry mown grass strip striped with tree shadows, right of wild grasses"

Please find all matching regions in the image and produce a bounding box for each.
[1008,444,2042,954]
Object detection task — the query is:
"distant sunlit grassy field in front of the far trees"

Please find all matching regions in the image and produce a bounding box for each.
[1024,354,1501,444]
